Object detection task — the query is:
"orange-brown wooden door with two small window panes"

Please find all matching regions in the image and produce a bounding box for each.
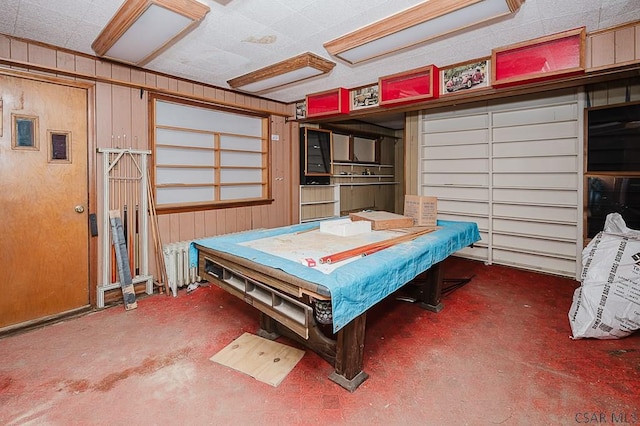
[0,74,89,329]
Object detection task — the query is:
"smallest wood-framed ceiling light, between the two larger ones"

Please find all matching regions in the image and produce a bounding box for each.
[227,52,336,93]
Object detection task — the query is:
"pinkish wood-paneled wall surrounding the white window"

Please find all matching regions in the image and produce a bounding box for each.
[0,35,299,286]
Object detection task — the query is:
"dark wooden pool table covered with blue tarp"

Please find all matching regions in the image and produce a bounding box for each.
[190,221,480,391]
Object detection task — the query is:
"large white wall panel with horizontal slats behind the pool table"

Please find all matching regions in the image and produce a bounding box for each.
[420,91,584,278]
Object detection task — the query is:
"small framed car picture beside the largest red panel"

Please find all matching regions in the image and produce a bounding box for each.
[440,58,491,96]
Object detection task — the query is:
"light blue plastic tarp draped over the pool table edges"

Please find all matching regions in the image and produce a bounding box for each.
[189,220,480,332]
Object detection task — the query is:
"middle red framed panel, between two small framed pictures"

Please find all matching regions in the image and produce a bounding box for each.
[378,65,439,106]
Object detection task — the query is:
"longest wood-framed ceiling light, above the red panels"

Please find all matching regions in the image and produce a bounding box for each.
[324,0,525,64]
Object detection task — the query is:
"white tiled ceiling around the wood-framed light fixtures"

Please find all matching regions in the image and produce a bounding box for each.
[0,0,640,126]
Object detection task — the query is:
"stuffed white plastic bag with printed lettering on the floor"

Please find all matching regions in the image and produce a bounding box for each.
[569,213,640,339]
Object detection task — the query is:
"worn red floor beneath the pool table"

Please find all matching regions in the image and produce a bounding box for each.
[0,258,640,425]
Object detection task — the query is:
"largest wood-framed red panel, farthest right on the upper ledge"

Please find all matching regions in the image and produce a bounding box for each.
[491,27,585,86]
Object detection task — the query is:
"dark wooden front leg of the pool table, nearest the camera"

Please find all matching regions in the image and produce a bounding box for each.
[329,312,369,392]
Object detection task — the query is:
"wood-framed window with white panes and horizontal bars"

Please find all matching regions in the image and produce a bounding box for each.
[152,95,269,210]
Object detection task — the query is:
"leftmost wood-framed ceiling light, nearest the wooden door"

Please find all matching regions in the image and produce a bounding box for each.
[91,0,209,65]
